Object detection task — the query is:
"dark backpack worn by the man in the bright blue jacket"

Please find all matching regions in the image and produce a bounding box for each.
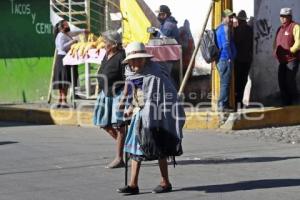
[200,30,220,63]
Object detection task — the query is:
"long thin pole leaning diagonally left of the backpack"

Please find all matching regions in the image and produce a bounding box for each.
[178,0,218,96]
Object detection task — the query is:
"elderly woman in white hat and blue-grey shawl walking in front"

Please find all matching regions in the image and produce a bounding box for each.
[117,42,185,194]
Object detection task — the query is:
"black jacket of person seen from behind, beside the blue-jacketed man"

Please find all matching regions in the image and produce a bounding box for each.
[234,22,253,62]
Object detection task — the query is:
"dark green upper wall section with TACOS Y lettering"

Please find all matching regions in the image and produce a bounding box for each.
[0,0,54,58]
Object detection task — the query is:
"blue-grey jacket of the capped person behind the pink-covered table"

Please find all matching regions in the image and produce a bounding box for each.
[160,16,179,42]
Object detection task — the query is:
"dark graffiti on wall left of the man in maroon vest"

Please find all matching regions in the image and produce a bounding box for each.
[254,19,273,54]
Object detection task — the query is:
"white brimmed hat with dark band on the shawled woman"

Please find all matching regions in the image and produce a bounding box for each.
[123,42,153,63]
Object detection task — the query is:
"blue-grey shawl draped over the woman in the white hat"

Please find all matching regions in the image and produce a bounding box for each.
[125,60,185,141]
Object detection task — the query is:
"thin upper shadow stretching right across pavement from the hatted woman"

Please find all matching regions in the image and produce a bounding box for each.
[177,157,300,165]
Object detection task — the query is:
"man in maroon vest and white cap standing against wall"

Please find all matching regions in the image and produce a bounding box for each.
[274,8,300,106]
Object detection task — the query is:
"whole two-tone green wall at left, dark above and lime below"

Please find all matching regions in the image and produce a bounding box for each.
[0,0,54,103]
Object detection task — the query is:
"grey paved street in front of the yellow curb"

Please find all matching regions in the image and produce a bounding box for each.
[0,122,300,200]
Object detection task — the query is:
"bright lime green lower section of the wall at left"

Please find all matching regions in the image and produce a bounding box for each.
[0,57,52,103]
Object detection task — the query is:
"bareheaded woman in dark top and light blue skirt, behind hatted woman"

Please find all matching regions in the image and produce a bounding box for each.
[94,31,125,168]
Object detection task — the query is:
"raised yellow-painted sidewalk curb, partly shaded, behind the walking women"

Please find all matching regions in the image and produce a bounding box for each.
[0,102,300,130]
